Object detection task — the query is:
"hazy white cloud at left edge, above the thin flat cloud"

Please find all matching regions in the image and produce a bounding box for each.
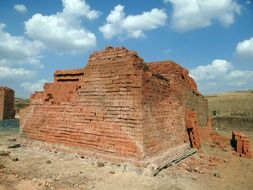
[0,23,43,65]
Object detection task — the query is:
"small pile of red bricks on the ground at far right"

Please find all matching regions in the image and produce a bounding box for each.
[232,131,252,158]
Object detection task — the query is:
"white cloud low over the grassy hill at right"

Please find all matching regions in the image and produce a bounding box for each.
[190,59,253,93]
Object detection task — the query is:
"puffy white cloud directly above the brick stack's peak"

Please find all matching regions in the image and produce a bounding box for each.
[99,5,167,39]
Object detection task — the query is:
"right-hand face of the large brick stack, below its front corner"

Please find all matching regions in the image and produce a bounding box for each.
[142,73,189,156]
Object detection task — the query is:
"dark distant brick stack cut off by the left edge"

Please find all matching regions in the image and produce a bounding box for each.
[0,87,15,120]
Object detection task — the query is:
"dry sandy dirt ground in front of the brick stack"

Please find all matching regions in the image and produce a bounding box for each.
[0,125,253,190]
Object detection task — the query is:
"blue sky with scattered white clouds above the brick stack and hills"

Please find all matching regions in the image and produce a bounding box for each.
[0,0,253,97]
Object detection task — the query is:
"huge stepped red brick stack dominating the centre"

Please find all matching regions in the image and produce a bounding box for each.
[20,47,208,171]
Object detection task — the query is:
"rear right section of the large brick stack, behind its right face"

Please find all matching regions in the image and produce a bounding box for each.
[148,61,208,127]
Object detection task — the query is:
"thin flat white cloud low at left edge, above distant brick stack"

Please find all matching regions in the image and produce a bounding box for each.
[0,66,35,80]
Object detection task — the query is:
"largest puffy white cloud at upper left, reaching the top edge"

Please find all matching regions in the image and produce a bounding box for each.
[25,0,99,53]
